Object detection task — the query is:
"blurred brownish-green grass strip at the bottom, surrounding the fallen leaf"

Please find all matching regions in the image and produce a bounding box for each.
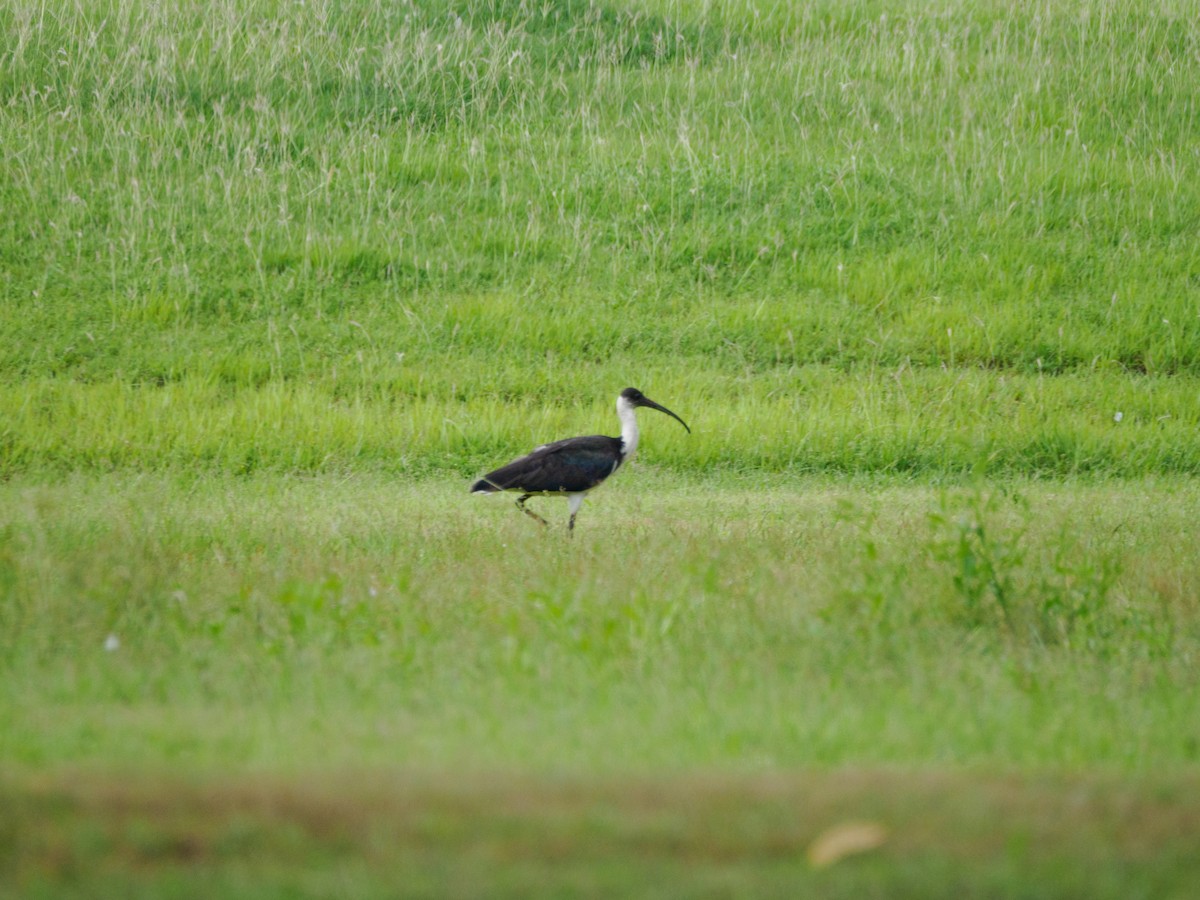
[0,769,1200,898]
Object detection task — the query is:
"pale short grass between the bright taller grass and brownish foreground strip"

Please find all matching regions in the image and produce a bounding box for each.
[0,472,1200,773]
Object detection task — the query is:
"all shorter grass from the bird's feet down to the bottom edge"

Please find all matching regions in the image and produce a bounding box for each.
[0,468,1200,896]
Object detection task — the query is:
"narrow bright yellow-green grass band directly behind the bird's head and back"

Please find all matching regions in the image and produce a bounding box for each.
[0,367,1200,479]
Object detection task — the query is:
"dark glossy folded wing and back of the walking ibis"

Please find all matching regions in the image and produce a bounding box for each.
[470,434,620,493]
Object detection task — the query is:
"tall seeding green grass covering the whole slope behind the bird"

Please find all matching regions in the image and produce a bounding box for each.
[0,0,1200,474]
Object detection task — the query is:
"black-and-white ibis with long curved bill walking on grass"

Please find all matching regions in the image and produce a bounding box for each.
[470,388,691,534]
